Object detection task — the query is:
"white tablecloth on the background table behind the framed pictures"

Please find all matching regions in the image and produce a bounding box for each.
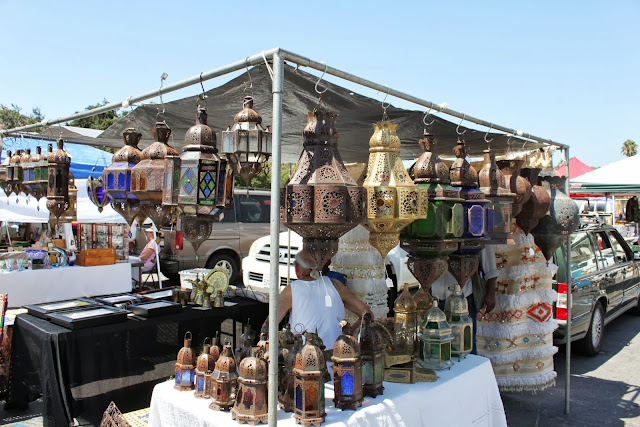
[0,262,131,307]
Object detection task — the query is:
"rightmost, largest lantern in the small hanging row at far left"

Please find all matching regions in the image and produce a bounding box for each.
[47,139,71,222]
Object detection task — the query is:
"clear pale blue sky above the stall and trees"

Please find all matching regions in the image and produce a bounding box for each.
[0,0,640,166]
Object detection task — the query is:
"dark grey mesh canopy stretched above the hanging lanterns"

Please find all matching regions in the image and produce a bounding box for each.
[96,66,543,163]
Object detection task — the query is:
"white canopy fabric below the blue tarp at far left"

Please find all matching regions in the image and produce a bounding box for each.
[0,179,125,224]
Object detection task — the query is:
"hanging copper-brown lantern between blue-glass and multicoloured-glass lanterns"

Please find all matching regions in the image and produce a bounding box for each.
[131,122,178,229]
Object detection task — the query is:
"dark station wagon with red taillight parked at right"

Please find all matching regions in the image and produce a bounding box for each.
[554,224,640,356]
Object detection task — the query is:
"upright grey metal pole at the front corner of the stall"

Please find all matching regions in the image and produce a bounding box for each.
[269,51,284,427]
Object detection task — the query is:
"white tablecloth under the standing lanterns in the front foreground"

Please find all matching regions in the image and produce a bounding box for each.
[149,355,507,427]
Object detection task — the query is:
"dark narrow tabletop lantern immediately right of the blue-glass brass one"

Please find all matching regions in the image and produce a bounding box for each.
[360,313,385,397]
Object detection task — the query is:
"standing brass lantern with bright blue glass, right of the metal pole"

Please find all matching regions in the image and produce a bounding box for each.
[331,321,363,410]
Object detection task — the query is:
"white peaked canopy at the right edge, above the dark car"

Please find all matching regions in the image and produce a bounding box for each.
[569,155,640,194]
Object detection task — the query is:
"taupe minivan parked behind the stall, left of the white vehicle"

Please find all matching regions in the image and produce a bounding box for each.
[160,188,271,283]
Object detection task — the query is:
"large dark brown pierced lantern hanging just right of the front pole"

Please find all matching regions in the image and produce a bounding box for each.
[280,111,367,267]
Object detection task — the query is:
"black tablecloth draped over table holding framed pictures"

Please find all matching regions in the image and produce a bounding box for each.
[5,298,268,426]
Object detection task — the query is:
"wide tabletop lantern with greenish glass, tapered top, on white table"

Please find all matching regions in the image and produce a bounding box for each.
[418,300,453,369]
